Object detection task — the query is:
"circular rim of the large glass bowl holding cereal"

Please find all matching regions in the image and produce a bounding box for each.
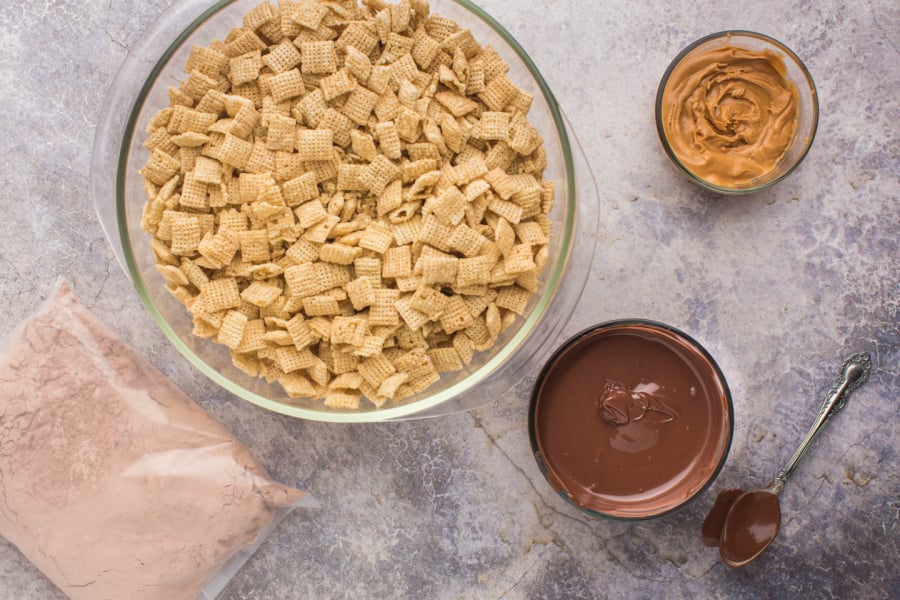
[113,0,577,423]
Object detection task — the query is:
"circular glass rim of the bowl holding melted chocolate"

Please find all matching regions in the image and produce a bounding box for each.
[528,318,734,522]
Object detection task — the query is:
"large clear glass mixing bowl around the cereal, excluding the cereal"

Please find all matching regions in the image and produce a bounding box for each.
[91,0,599,423]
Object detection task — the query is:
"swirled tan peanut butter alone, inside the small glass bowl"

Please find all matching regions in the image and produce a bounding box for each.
[660,46,799,188]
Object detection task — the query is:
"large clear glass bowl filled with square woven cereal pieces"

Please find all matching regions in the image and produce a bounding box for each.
[91,0,598,422]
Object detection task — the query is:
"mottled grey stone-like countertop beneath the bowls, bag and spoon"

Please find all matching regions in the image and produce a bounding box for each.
[0,0,900,600]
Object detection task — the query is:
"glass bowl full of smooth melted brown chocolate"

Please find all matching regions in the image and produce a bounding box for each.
[529,320,734,520]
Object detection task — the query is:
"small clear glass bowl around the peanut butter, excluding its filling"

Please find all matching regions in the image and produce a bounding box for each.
[656,30,819,194]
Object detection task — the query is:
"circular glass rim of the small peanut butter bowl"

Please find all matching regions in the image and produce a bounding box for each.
[655,29,819,195]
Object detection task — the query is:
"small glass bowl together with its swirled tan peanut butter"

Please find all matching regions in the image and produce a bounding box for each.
[656,32,818,193]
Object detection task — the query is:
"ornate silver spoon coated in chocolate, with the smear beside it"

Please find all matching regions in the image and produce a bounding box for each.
[703,352,872,567]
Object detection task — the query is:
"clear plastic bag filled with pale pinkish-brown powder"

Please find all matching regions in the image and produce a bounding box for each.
[0,283,314,600]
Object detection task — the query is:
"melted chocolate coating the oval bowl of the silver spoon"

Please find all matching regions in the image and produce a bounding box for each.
[719,491,781,566]
